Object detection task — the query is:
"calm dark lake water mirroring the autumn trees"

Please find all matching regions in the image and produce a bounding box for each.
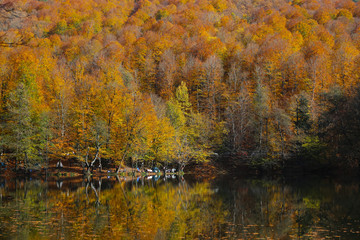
[0,176,360,239]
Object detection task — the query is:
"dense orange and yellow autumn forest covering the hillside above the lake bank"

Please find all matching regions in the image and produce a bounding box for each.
[0,0,360,173]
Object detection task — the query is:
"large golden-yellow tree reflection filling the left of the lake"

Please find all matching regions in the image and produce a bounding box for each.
[0,177,226,239]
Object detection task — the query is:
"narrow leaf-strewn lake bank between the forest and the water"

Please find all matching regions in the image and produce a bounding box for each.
[0,158,359,180]
